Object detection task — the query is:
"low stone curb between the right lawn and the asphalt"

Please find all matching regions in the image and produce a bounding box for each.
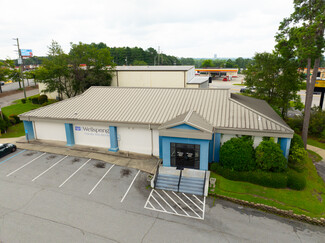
[209,193,325,226]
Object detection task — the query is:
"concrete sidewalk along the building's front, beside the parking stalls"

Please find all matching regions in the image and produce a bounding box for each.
[0,136,158,174]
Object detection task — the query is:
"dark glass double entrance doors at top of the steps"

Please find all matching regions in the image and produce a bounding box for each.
[170,143,200,169]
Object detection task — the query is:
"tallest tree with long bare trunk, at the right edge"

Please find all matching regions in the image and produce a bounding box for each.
[276,0,325,148]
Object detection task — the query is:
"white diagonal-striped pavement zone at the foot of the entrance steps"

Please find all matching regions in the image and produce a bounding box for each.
[144,189,205,220]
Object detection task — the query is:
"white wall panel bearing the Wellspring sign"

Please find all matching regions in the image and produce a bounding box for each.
[73,124,110,149]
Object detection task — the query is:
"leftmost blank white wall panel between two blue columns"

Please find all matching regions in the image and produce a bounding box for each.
[34,121,67,141]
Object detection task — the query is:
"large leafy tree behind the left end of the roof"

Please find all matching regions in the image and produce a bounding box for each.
[35,41,114,99]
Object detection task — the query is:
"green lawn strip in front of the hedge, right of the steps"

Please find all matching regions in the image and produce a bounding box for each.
[210,158,325,218]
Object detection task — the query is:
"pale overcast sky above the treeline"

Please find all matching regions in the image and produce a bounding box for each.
[0,0,293,59]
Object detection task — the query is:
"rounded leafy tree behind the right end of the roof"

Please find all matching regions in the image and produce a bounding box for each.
[245,52,301,117]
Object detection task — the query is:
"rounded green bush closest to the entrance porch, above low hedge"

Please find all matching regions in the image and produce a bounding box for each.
[220,137,256,171]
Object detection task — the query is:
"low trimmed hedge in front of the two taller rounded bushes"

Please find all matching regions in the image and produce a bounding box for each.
[210,163,287,188]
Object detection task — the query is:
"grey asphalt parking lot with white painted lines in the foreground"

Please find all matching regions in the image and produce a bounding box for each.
[0,149,325,242]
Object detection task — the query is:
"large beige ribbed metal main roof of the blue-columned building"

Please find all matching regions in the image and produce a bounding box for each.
[20,86,293,137]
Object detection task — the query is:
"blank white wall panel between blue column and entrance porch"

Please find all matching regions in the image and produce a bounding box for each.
[117,127,159,155]
